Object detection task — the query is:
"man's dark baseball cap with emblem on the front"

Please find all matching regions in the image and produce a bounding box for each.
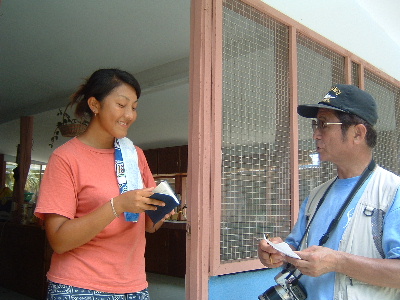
[297,84,378,125]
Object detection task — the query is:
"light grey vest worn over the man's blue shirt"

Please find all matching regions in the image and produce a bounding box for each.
[301,166,400,300]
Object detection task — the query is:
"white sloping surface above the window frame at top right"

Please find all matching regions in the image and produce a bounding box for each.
[262,0,400,80]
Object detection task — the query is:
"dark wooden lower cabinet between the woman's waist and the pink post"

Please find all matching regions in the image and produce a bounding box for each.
[145,222,186,278]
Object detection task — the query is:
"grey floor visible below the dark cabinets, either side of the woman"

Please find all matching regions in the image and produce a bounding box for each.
[0,273,185,300]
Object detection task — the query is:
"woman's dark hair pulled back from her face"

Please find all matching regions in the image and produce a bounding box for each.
[69,69,141,118]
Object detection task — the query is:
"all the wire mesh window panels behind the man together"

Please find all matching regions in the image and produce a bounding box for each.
[220,0,400,262]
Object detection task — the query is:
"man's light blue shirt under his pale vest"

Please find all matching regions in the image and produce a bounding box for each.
[286,176,400,300]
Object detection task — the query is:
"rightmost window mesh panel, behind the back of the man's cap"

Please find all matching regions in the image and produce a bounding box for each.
[365,70,400,174]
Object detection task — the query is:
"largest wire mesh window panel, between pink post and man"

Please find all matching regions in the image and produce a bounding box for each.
[220,1,291,262]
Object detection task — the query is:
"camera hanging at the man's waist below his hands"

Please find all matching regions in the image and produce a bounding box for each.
[258,265,307,300]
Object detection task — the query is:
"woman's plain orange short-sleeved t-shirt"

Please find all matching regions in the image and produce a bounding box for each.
[35,138,155,293]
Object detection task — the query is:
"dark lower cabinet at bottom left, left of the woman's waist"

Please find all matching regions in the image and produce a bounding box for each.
[0,222,53,300]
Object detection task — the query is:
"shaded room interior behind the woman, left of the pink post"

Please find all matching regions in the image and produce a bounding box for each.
[0,0,190,300]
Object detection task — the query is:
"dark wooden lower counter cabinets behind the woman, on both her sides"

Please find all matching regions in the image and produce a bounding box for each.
[0,222,186,300]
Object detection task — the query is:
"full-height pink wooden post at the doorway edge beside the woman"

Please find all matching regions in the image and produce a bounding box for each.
[186,0,216,300]
